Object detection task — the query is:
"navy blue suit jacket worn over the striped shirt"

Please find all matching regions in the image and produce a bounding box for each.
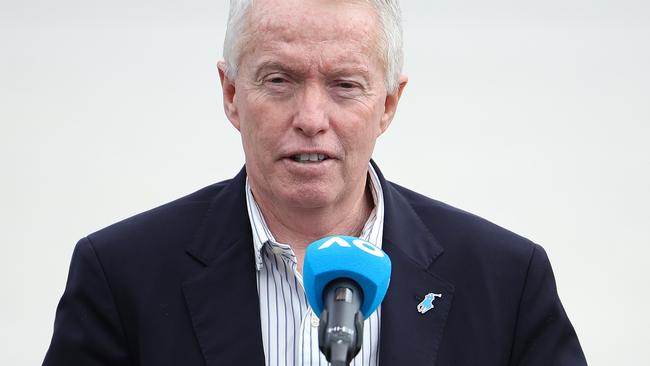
[44,164,586,366]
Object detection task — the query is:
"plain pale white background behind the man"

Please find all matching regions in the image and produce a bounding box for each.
[0,0,650,365]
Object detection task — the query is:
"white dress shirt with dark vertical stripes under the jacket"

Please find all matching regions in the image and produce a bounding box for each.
[246,165,384,366]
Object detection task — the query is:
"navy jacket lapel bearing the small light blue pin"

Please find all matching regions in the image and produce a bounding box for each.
[373,162,454,366]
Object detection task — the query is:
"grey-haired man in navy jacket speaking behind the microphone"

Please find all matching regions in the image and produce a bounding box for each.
[44,0,586,365]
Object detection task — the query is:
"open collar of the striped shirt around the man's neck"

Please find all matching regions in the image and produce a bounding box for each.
[245,164,384,271]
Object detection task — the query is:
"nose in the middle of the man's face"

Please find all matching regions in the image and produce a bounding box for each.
[293,83,329,137]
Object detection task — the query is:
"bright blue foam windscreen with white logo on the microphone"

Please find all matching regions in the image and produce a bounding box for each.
[303,236,391,319]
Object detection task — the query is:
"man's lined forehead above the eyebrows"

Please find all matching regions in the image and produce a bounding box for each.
[242,0,379,72]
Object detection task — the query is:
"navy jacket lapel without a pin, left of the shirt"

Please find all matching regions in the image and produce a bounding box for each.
[183,169,264,366]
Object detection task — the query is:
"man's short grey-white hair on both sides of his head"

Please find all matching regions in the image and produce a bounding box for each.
[223,0,404,94]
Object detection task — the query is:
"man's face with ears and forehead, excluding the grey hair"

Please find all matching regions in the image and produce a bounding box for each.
[220,0,405,208]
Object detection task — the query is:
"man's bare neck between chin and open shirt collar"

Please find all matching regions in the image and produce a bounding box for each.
[251,177,374,272]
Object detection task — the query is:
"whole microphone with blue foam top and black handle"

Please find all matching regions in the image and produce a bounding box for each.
[303,236,391,366]
